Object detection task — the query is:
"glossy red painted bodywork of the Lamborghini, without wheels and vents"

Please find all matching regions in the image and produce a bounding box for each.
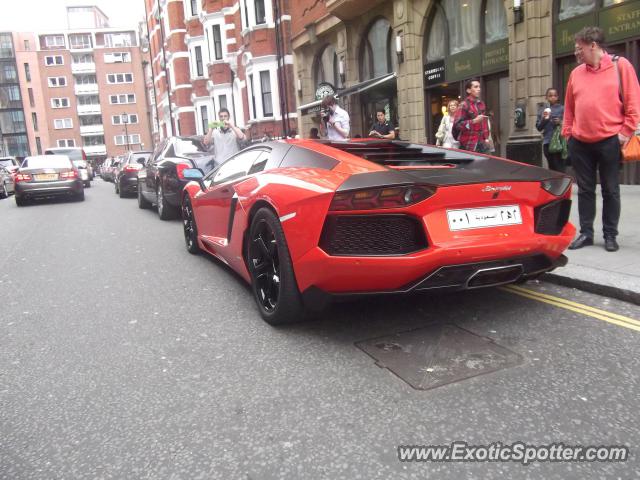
[184,140,575,294]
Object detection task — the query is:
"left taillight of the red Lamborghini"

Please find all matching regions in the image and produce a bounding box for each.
[329,185,436,212]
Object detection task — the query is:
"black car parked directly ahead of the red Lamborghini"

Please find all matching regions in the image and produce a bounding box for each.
[138,137,218,220]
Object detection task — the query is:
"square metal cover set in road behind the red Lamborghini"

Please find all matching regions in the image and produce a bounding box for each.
[356,324,522,390]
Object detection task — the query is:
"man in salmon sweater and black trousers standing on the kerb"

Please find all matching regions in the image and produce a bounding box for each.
[562,27,640,252]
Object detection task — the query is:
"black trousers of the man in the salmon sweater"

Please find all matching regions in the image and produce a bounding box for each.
[569,135,620,238]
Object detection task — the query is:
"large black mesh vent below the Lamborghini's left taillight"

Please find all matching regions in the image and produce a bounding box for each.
[320,215,427,256]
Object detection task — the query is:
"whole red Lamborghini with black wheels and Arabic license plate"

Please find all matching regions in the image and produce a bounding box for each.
[182,140,575,324]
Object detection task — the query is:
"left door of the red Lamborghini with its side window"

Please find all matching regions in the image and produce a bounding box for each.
[196,148,264,249]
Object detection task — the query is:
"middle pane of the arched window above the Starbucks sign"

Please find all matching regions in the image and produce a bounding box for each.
[442,0,482,55]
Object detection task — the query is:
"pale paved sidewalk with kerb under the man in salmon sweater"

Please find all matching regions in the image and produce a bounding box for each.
[541,185,640,305]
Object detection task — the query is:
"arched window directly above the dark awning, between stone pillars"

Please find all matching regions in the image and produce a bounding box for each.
[360,18,393,81]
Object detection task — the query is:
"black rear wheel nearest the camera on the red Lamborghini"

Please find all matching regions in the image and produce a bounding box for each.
[247,207,303,325]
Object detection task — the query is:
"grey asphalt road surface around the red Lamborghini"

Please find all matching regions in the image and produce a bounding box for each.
[0,179,640,480]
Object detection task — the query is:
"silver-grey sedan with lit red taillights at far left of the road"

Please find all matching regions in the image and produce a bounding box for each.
[15,155,84,207]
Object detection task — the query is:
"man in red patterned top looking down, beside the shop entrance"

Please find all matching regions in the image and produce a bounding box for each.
[453,79,489,153]
